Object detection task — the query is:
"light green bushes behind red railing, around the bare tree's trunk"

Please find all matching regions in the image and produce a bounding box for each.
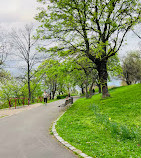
[0,75,43,108]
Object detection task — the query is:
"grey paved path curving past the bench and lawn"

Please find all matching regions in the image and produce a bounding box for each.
[0,100,77,158]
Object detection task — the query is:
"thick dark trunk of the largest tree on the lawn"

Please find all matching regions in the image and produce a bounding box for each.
[97,60,110,98]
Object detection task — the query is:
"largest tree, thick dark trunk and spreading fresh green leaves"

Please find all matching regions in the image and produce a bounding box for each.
[36,0,141,97]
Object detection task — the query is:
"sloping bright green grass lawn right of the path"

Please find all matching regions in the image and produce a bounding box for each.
[56,84,141,158]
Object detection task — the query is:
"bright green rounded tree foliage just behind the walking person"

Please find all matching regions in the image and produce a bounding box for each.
[36,59,68,93]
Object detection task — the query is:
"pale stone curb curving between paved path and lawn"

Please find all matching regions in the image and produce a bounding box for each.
[52,111,92,158]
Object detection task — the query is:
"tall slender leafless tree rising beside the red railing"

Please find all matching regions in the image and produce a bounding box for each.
[10,24,38,100]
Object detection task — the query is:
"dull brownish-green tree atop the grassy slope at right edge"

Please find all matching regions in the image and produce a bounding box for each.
[122,51,141,85]
